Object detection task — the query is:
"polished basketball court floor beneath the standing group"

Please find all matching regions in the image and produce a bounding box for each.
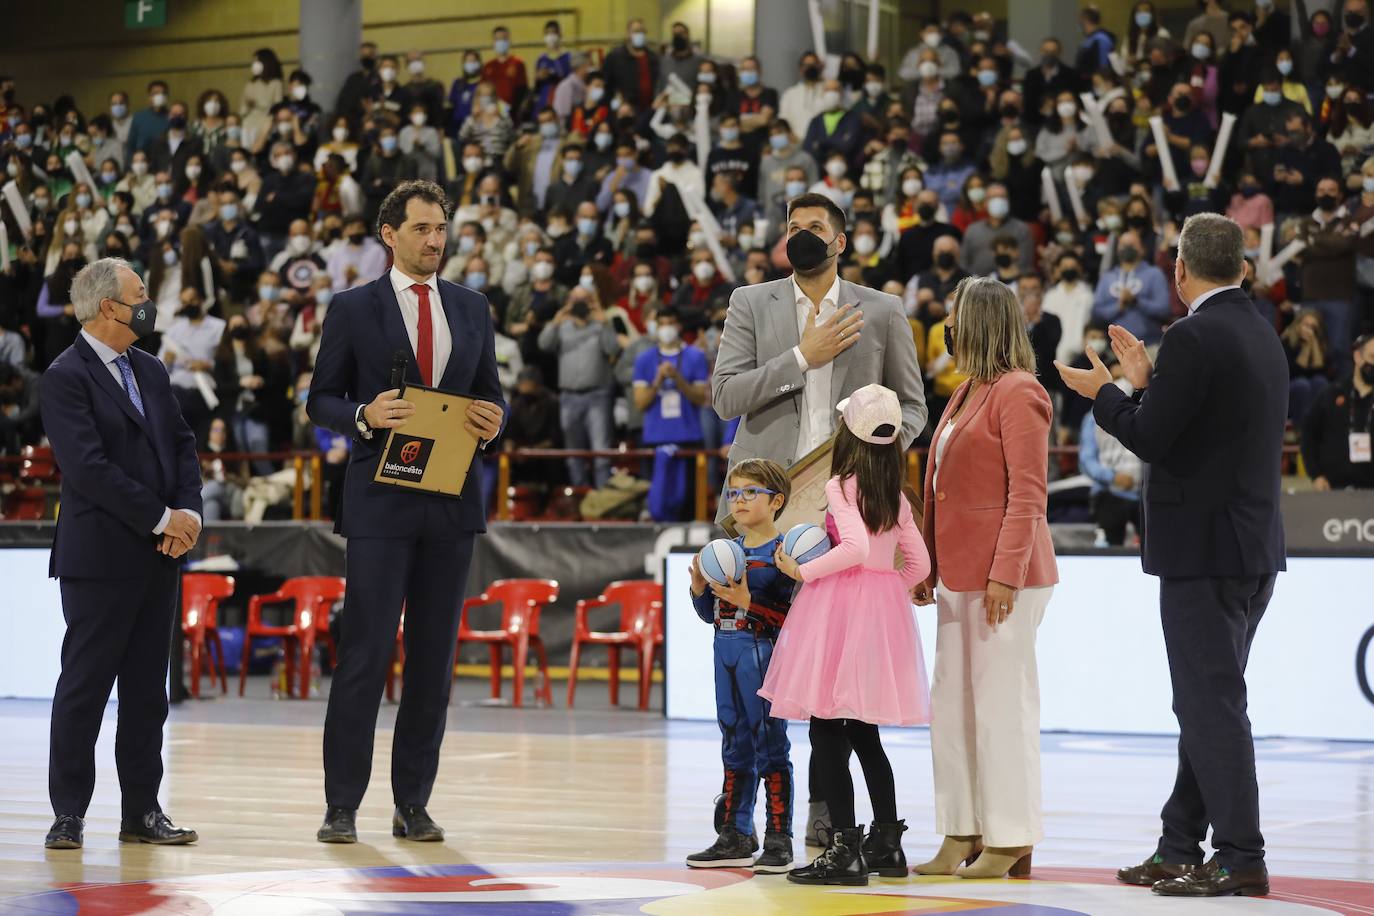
[0,678,1374,916]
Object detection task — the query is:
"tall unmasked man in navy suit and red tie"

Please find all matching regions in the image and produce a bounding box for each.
[306,181,506,843]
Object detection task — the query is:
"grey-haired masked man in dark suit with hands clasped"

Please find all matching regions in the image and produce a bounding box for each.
[40,258,201,849]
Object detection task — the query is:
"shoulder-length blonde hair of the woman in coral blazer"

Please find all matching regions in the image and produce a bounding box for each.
[947,277,1035,382]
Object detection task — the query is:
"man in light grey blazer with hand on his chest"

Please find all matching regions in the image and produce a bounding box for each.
[710,194,926,522]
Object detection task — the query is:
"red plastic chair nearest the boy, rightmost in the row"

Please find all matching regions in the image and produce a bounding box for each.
[567,580,664,710]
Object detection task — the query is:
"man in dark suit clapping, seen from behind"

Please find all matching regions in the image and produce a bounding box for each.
[1059,213,1289,897]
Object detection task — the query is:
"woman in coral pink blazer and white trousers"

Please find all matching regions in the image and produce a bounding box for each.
[914,279,1059,878]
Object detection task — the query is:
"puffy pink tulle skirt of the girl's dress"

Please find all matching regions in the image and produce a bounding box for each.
[758,566,930,725]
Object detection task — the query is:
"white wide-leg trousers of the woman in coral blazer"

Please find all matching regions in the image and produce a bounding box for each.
[930,582,1054,846]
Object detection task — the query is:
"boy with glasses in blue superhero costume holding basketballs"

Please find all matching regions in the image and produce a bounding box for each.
[687,459,797,873]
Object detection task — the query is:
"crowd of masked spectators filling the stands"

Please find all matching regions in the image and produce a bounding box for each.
[0,0,1374,521]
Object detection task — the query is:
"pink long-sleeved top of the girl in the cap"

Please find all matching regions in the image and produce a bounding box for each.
[800,477,930,589]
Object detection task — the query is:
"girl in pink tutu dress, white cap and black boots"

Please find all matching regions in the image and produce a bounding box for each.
[758,385,930,884]
